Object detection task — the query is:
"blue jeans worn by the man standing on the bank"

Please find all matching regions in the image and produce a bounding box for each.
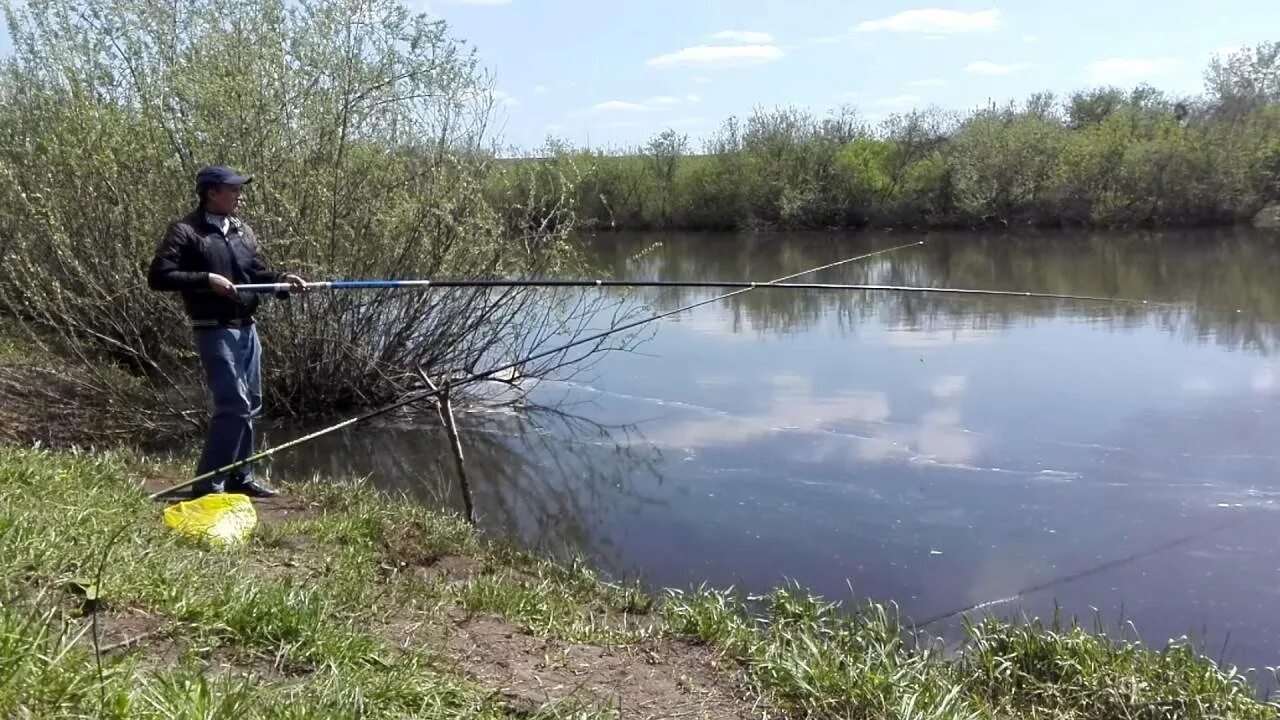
[193,325,262,492]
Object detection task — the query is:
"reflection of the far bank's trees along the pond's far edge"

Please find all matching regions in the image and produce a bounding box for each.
[593,228,1280,352]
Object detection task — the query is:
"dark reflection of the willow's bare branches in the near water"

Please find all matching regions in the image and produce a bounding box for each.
[271,405,666,571]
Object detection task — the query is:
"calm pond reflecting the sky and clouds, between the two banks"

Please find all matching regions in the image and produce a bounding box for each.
[269,229,1280,684]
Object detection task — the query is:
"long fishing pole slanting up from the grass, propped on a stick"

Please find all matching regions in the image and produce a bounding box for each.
[148,240,924,500]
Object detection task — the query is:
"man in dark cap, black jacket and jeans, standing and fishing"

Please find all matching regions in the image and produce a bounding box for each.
[147,165,307,497]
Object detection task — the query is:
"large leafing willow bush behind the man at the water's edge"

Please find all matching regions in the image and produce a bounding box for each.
[0,0,640,438]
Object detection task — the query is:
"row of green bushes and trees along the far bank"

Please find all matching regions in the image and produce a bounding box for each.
[497,41,1280,229]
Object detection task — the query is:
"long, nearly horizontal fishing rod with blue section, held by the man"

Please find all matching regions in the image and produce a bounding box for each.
[236,279,1185,307]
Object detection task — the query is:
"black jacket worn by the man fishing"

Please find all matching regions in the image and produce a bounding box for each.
[147,209,284,325]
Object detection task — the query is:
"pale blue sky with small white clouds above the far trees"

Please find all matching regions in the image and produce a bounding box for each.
[0,0,1280,150]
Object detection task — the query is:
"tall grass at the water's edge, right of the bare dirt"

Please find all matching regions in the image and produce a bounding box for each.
[663,588,1280,720]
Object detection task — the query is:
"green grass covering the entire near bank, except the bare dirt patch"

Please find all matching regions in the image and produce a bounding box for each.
[0,448,1280,720]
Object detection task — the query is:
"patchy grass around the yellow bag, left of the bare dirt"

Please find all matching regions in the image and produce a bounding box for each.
[0,451,634,717]
